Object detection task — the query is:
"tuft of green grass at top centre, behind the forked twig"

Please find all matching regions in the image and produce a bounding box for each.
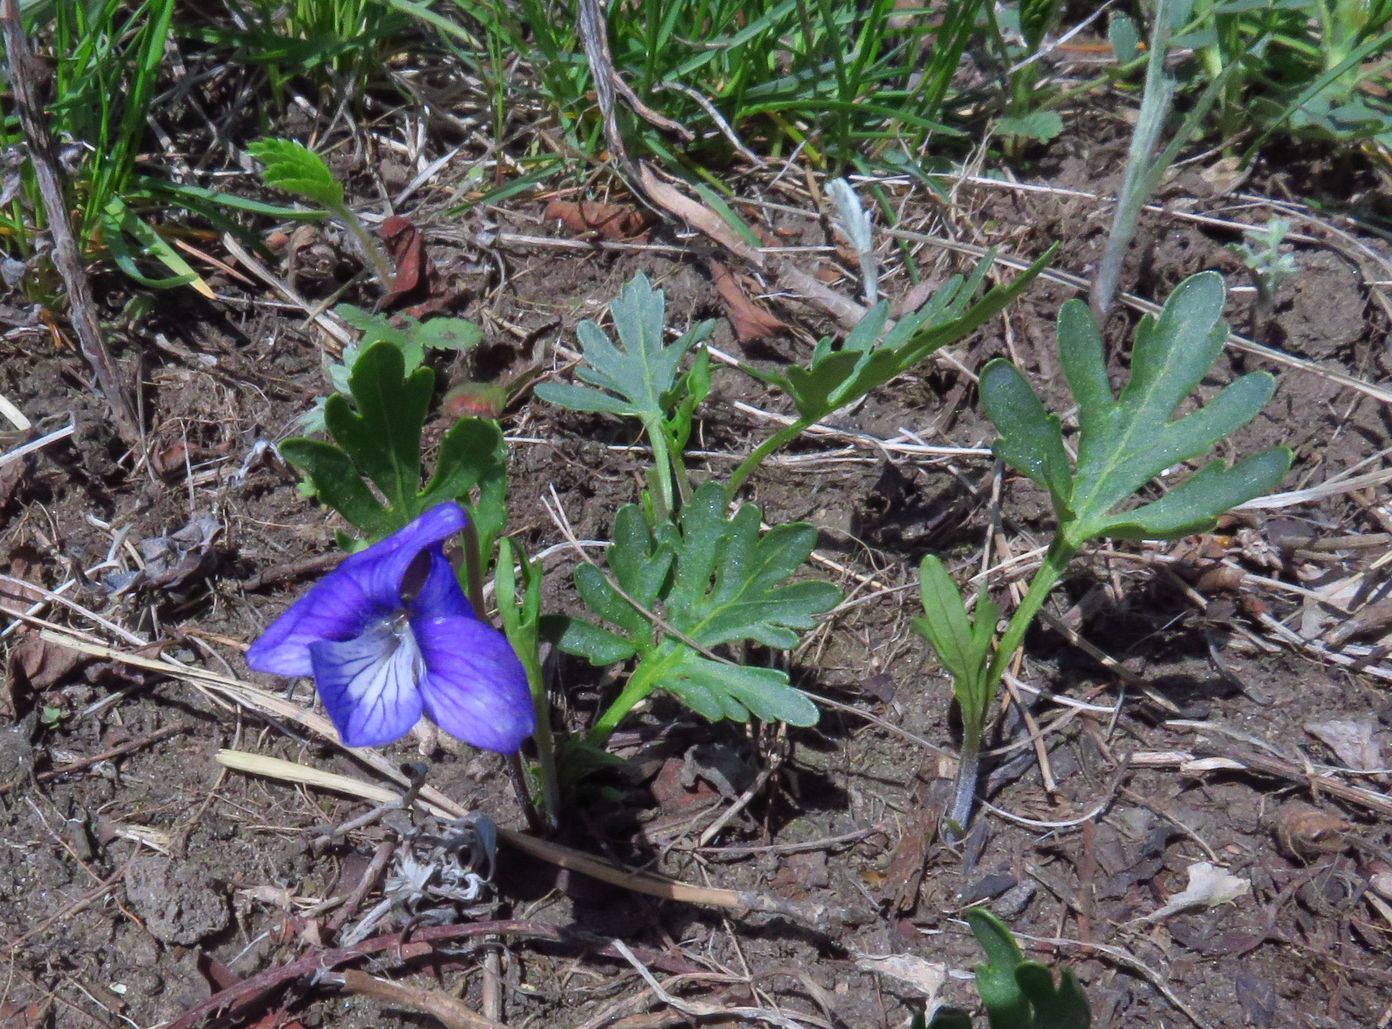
[437,0,986,171]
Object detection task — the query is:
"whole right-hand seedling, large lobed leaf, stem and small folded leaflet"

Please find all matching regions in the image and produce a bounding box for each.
[920,272,1290,827]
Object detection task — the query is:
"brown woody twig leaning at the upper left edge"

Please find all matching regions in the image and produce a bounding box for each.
[0,0,141,448]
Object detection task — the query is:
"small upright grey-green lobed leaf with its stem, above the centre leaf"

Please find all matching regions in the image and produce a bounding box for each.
[536,273,715,518]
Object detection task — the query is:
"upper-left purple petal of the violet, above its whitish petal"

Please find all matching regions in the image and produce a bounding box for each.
[246,503,468,675]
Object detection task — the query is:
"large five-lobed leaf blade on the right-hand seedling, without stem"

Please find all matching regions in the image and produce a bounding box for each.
[981,272,1290,547]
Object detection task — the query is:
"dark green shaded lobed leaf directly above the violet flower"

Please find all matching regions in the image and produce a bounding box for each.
[280,340,507,548]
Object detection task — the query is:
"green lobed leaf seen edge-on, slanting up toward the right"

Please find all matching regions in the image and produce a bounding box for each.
[745,248,1055,423]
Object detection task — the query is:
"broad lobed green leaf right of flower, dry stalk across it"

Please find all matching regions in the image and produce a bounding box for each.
[560,482,839,742]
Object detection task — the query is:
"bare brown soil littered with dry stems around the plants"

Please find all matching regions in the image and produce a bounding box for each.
[0,124,1392,1029]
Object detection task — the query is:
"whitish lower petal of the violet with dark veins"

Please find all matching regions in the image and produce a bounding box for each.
[309,621,423,746]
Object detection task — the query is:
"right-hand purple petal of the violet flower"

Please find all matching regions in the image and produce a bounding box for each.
[411,618,536,753]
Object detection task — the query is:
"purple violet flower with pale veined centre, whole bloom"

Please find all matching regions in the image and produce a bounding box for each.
[246,503,536,753]
